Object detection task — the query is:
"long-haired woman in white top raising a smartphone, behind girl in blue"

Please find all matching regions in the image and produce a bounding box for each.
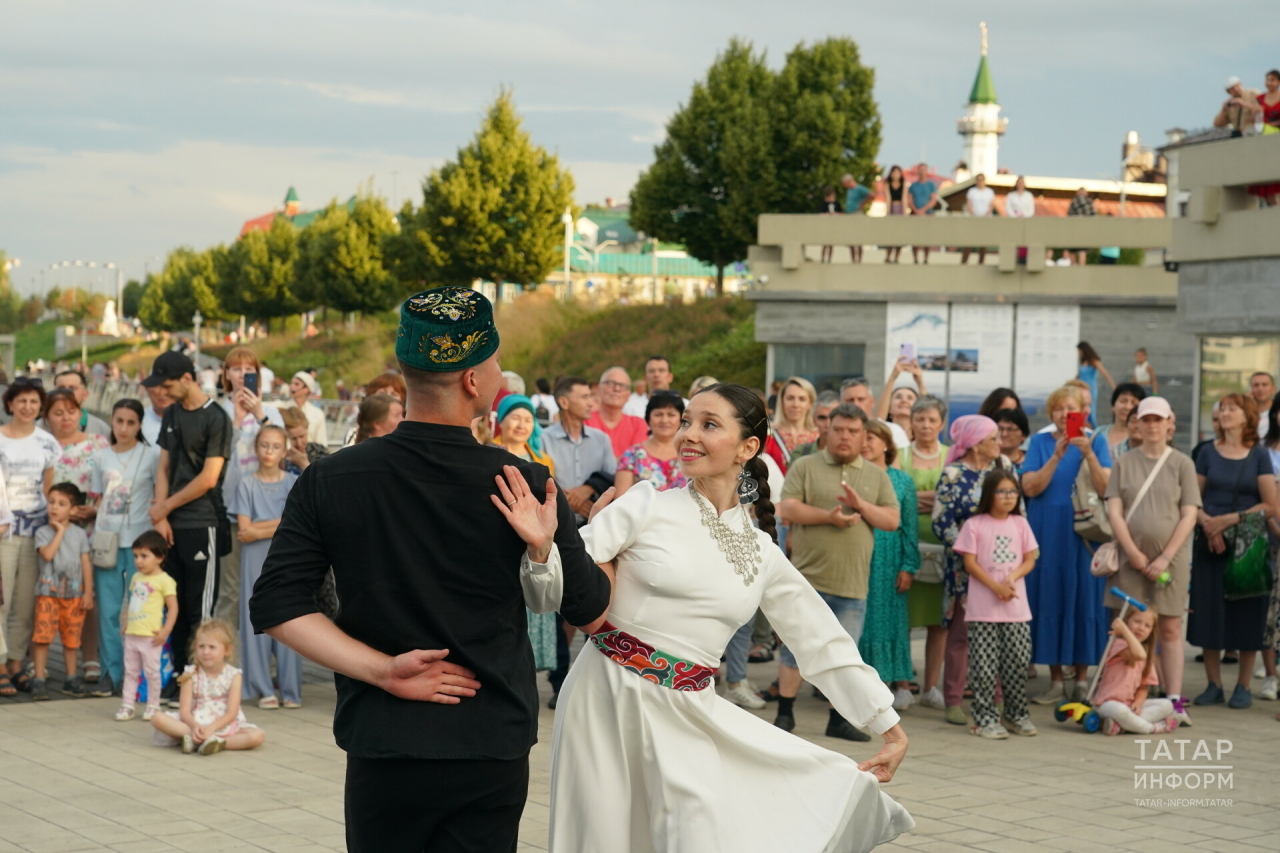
[214,347,284,628]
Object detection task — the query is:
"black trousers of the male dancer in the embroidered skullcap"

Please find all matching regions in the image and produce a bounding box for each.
[346,756,529,853]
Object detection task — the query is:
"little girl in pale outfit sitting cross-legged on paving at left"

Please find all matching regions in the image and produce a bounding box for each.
[151,619,266,756]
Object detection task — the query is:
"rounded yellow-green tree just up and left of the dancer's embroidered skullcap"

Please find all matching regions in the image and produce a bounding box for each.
[294,195,404,313]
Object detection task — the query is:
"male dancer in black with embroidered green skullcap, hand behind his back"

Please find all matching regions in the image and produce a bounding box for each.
[250,287,609,853]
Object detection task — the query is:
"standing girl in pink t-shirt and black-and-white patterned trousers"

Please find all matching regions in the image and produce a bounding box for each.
[955,467,1039,740]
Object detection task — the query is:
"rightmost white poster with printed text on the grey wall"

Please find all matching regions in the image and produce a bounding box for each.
[1014,305,1080,415]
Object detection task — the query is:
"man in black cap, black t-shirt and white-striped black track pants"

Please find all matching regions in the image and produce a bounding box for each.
[142,352,232,686]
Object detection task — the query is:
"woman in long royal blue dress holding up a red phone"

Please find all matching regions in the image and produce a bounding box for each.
[1021,384,1111,704]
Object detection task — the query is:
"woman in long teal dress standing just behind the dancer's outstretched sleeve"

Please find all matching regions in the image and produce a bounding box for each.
[858,420,920,711]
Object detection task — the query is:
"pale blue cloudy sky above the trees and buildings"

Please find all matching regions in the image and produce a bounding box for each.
[0,0,1280,291]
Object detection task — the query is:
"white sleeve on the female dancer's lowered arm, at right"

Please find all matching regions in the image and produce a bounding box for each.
[760,548,899,734]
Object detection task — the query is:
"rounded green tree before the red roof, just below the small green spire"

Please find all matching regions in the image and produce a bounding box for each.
[218,216,305,320]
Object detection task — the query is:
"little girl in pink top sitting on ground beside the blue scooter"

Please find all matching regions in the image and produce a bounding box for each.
[1093,607,1178,735]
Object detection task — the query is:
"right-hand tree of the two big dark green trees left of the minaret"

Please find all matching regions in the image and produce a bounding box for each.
[762,38,881,213]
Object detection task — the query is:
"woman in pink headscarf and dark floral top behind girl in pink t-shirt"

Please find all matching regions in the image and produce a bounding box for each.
[933,415,1018,726]
